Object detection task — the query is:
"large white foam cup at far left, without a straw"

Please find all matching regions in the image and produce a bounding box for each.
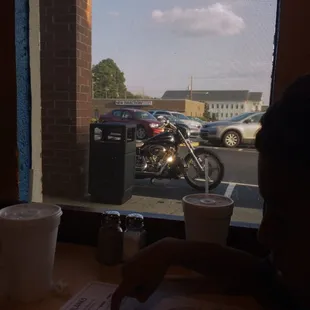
[0,203,62,302]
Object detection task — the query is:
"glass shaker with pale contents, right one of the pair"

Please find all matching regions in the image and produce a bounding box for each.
[123,213,146,261]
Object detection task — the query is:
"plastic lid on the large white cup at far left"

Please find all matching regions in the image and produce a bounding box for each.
[0,203,62,230]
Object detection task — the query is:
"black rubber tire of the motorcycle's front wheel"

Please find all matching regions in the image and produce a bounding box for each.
[184,148,224,191]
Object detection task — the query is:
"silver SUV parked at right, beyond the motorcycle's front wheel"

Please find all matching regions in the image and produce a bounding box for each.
[200,112,264,148]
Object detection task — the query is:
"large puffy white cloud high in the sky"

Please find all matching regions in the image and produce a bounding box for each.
[152,3,245,36]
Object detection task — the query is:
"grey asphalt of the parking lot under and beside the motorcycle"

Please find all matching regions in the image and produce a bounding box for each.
[134,147,263,210]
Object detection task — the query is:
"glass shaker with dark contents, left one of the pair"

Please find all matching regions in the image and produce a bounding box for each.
[97,211,123,266]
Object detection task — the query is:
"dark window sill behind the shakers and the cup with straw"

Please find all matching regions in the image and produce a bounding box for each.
[58,205,266,256]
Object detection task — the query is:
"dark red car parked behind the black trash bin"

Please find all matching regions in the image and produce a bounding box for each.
[99,108,164,140]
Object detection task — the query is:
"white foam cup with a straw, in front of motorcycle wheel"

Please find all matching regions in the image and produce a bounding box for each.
[182,194,234,245]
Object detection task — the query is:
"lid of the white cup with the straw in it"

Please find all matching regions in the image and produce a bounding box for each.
[182,193,234,216]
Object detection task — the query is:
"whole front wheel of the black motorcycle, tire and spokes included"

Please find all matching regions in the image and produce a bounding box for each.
[184,148,224,191]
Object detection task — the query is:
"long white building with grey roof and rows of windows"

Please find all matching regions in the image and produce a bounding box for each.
[162,90,263,120]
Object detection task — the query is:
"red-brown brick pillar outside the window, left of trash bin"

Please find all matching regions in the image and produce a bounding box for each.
[40,0,92,198]
